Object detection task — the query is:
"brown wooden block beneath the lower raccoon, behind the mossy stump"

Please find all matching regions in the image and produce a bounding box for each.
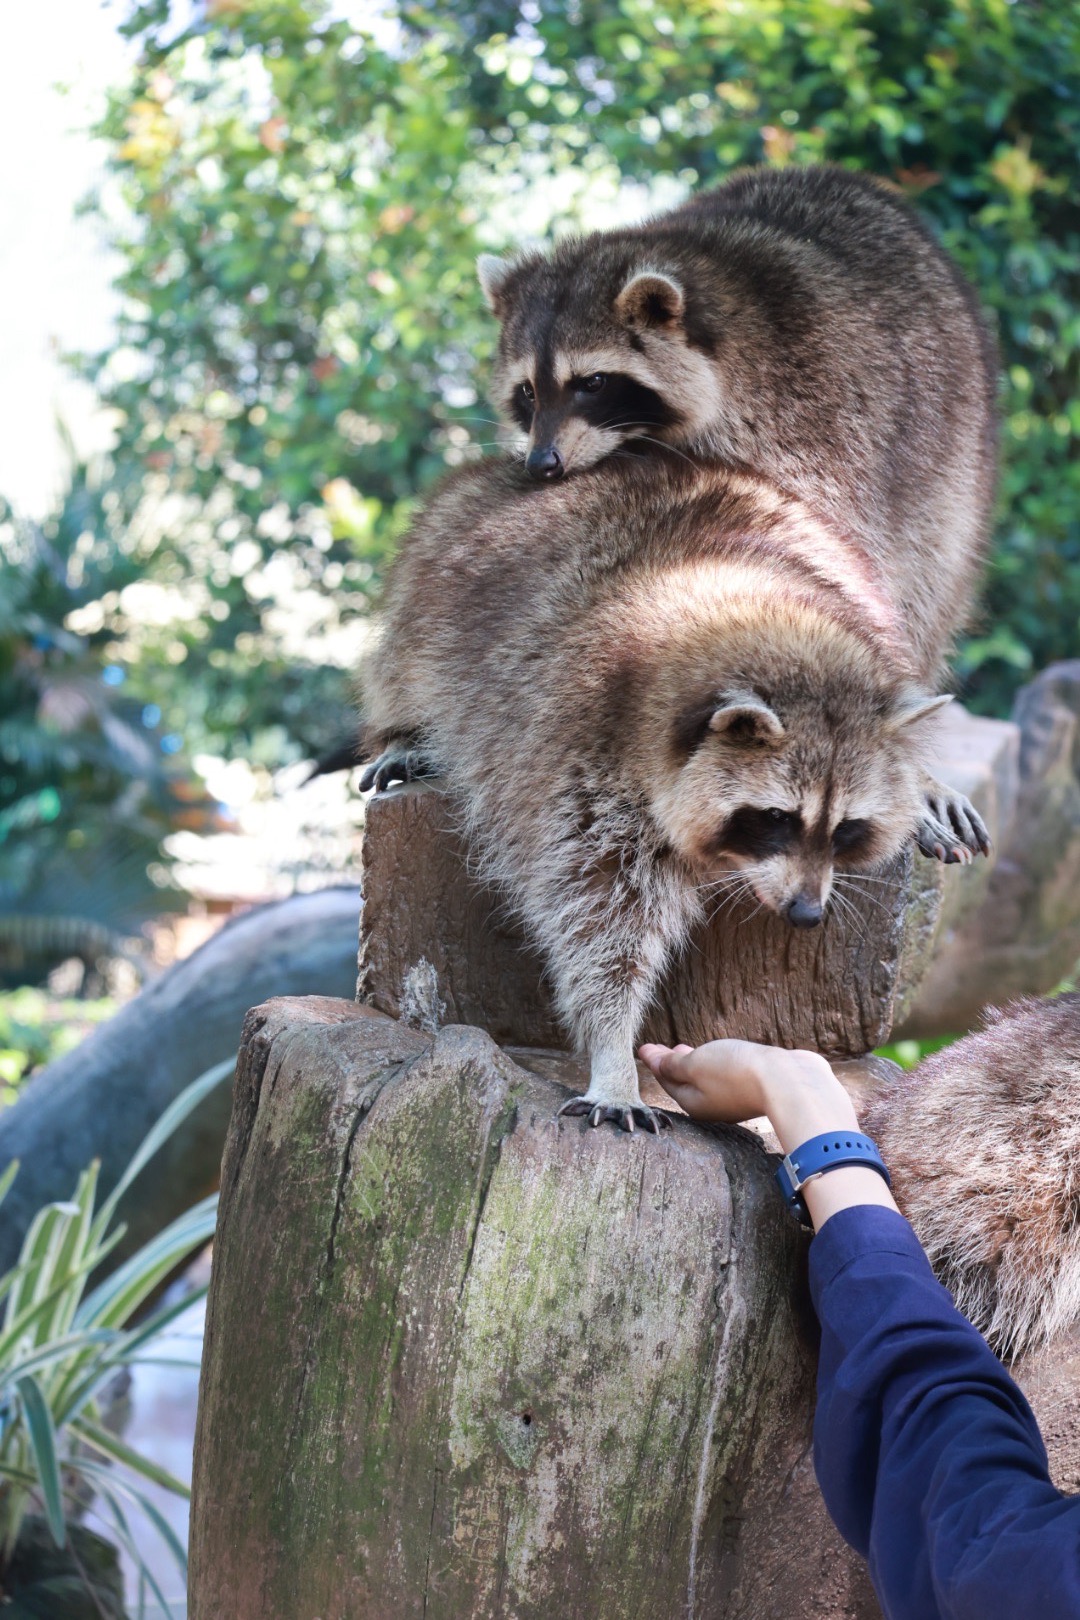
[359,711,1017,1058]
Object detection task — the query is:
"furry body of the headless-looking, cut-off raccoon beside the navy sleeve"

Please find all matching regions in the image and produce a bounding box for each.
[863,995,1080,1356]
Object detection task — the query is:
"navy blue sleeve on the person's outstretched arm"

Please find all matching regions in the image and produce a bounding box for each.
[810,1204,1080,1620]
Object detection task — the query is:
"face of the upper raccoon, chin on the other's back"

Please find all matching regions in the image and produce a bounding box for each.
[478,246,716,481]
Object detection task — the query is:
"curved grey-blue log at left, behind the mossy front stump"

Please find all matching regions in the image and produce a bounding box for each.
[0,888,359,1270]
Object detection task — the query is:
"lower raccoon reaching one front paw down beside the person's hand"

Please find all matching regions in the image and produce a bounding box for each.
[364,460,988,1129]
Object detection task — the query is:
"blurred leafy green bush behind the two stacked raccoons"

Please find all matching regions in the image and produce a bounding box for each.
[78,0,1080,758]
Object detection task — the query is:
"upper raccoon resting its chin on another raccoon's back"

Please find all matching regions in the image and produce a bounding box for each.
[478,168,997,657]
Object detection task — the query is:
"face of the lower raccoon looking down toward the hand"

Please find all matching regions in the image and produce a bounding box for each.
[657,692,949,928]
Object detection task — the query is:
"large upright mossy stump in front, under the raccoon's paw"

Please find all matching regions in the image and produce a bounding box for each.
[189,1000,879,1620]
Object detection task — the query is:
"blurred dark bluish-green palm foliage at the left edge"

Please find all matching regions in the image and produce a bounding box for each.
[0,468,217,984]
